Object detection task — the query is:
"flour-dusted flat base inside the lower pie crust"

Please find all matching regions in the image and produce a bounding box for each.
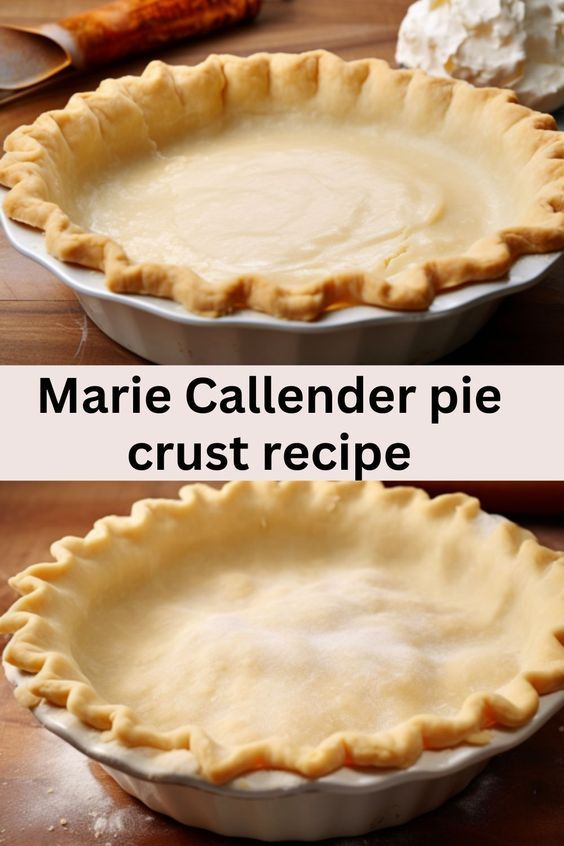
[73,537,525,746]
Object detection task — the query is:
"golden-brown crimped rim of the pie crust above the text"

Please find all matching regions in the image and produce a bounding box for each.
[0,50,564,320]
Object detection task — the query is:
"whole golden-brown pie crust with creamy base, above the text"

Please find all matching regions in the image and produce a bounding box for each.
[0,51,564,320]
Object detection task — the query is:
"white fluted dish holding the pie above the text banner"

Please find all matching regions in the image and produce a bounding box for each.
[0,205,563,364]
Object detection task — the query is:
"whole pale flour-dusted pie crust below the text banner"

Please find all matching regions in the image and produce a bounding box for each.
[0,482,564,783]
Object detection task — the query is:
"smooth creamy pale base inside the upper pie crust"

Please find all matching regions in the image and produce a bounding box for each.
[75,114,511,284]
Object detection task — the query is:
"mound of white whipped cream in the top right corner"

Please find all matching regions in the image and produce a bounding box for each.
[396,0,564,111]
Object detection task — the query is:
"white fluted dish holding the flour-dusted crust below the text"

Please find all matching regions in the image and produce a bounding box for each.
[3,662,564,841]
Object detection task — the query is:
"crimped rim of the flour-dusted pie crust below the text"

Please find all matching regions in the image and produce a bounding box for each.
[0,482,564,784]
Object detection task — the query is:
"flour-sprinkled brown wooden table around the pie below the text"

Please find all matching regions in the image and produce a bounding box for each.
[0,482,564,846]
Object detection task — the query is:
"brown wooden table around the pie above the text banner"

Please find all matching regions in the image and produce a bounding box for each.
[0,0,564,364]
